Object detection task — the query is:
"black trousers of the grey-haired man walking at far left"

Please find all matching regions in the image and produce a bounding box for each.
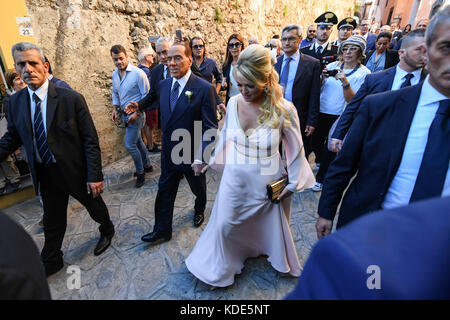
[35,163,114,266]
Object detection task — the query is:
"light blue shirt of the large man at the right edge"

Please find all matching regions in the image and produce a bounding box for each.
[382,76,450,209]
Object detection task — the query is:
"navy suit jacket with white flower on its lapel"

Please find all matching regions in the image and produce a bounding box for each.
[138,73,217,170]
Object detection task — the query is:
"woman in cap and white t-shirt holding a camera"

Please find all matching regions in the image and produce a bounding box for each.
[312,35,370,191]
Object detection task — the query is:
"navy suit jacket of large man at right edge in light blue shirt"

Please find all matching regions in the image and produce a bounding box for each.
[318,82,423,227]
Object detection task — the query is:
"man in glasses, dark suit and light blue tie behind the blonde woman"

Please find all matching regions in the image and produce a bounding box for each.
[275,25,321,157]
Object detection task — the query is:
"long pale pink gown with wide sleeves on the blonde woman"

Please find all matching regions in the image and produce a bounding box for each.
[186,94,315,287]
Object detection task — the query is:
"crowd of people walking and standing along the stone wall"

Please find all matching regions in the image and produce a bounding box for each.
[0,7,450,298]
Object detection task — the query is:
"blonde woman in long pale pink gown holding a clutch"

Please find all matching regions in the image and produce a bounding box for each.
[186,44,315,287]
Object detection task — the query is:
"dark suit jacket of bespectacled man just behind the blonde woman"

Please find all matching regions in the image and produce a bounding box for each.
[274,54,321,131]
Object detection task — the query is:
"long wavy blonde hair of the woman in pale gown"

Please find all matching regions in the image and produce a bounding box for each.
[233,44,290,128]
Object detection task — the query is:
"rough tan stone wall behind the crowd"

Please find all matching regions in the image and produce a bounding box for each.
[26,0,354,164]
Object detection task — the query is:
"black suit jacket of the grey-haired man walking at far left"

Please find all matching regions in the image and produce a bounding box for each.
[0,81,103,194]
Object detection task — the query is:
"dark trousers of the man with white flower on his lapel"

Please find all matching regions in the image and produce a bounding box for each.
[153,166,206,235]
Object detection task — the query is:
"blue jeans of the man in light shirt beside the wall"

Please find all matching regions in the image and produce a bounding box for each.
[124,114,150,173]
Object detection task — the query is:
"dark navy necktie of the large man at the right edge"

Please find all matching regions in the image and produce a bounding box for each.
[409,99,450,202]
